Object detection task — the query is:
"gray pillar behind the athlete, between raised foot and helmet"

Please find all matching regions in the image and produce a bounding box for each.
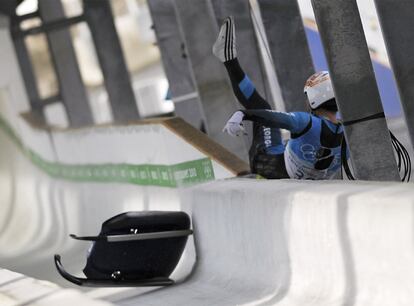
[258,0,315,112]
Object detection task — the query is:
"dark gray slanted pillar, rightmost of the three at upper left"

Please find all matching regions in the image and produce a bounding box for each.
[83,0,139,122]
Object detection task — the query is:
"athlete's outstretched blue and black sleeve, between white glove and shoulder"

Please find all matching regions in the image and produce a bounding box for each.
[242,109,312,134]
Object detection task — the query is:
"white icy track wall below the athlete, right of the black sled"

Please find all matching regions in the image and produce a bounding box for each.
[121,179,414,306]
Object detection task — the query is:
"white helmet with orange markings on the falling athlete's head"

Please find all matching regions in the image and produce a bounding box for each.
[304,71,335,109]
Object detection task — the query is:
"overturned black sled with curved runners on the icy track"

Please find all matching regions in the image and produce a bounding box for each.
[54,211,193,287]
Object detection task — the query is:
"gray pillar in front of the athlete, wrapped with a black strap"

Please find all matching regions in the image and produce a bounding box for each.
[312,0,399,181]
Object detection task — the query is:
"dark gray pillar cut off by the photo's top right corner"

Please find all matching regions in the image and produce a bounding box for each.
[375,0,414,151]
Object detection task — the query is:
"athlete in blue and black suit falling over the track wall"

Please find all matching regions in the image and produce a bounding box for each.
[213,17,343,180]
